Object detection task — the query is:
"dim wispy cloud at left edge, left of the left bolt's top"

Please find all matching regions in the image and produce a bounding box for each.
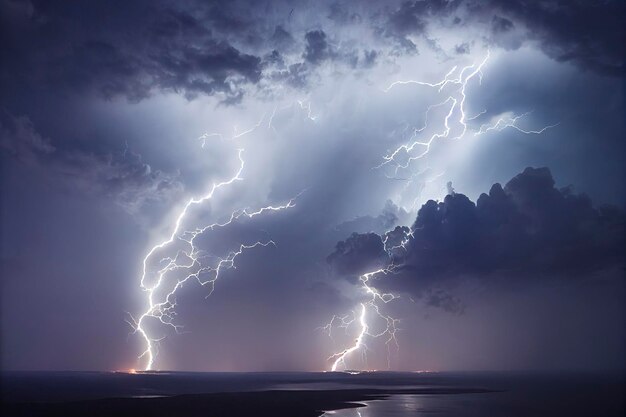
[0,113,183,214]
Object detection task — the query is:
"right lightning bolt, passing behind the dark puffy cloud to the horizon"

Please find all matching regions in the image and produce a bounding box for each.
[321,51,558,371]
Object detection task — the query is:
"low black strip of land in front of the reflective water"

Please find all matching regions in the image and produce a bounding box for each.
[2,387,496,417]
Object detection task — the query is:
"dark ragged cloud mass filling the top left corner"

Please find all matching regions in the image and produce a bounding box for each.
[0,2,261,101]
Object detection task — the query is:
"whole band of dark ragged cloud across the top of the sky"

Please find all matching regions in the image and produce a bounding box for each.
[0,0,624,103]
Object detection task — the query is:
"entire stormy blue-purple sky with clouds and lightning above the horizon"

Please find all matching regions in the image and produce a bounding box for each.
[0,0,626,371]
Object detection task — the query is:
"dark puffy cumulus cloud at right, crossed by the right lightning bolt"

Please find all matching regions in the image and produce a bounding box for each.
[328,168,625,298]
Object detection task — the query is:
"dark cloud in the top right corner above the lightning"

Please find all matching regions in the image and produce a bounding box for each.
[383,0,626,75]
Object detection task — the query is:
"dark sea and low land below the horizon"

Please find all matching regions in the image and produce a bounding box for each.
[1,372,625,417]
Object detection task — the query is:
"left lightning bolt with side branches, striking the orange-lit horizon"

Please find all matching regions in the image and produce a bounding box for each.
[127,122,301,371]
